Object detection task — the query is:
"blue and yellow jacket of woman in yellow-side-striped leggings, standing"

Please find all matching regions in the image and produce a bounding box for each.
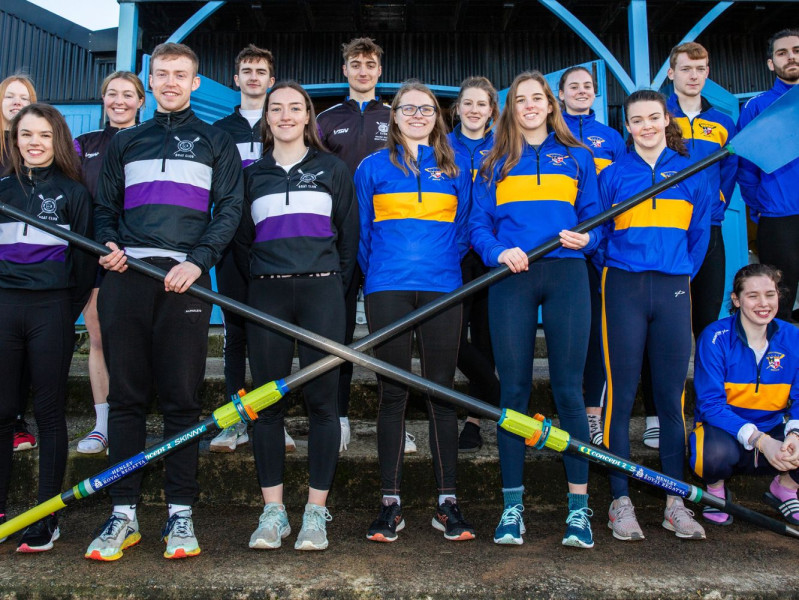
[594,148,717,277]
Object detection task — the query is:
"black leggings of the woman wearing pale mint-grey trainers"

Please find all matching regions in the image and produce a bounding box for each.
[247,275,344,490]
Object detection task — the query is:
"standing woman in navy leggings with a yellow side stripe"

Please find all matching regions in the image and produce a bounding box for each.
[599,90,711,540]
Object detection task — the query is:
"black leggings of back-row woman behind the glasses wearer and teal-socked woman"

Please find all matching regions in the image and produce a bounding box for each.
[458,250,499,417]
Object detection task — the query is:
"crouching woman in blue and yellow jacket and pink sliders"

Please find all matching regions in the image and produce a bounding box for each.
[689,264,799,525]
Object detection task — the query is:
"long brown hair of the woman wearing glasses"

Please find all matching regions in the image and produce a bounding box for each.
[386,79,458,177]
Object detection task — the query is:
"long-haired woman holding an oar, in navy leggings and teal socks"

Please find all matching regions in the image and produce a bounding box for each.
[471,71,599,548]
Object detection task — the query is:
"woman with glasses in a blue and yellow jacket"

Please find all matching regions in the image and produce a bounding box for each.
[355,81,474,542]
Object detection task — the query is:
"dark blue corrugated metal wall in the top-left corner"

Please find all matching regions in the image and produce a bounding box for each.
[0,10,115,104]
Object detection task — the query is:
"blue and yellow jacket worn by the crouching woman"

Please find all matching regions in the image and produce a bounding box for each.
[694,314,799,437]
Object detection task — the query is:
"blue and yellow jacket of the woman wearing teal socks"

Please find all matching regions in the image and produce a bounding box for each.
[470,133,599,267]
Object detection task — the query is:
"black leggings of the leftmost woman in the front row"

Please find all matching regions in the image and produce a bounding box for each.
[0,289,75,513]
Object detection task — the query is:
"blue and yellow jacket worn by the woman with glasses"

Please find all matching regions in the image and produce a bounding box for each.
[355,145,472,294]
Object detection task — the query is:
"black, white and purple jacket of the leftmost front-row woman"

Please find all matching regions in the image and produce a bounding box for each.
[0,166,97,318]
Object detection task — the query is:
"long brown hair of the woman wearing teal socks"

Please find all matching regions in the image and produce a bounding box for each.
[480,71,590,181]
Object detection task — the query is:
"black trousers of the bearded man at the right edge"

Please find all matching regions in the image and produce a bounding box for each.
[757,215,799,321]
